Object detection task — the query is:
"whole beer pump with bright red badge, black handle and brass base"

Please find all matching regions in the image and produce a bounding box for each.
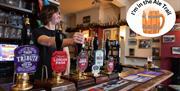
[51,22,68,84]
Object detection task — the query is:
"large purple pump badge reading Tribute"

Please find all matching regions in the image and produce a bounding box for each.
[14,45,39,73]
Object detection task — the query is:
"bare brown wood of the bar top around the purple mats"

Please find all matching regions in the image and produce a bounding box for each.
[119,68,173,91]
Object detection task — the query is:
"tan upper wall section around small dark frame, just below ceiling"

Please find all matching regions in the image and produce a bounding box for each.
[76,7,99,24]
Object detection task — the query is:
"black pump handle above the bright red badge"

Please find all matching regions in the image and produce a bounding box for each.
[55,30,63,51]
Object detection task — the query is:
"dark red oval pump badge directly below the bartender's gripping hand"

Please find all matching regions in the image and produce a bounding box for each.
[77,51,88,72]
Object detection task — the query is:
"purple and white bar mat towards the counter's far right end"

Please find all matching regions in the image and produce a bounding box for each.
[123,71,163,82]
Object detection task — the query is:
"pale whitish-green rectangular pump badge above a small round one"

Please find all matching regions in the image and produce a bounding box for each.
[95,50,104,67]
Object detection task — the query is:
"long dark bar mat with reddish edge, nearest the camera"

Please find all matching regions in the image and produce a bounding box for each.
[80,79,139,91]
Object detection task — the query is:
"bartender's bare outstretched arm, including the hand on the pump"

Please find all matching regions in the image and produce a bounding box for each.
[37,32,84,47]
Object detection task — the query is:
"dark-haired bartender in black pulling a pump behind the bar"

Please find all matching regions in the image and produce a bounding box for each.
[33,5,84,79]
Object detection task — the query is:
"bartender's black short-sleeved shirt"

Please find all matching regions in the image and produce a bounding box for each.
[33,27,65,79]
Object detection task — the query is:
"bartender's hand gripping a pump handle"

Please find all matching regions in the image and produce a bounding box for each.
[73,32,84,44]
